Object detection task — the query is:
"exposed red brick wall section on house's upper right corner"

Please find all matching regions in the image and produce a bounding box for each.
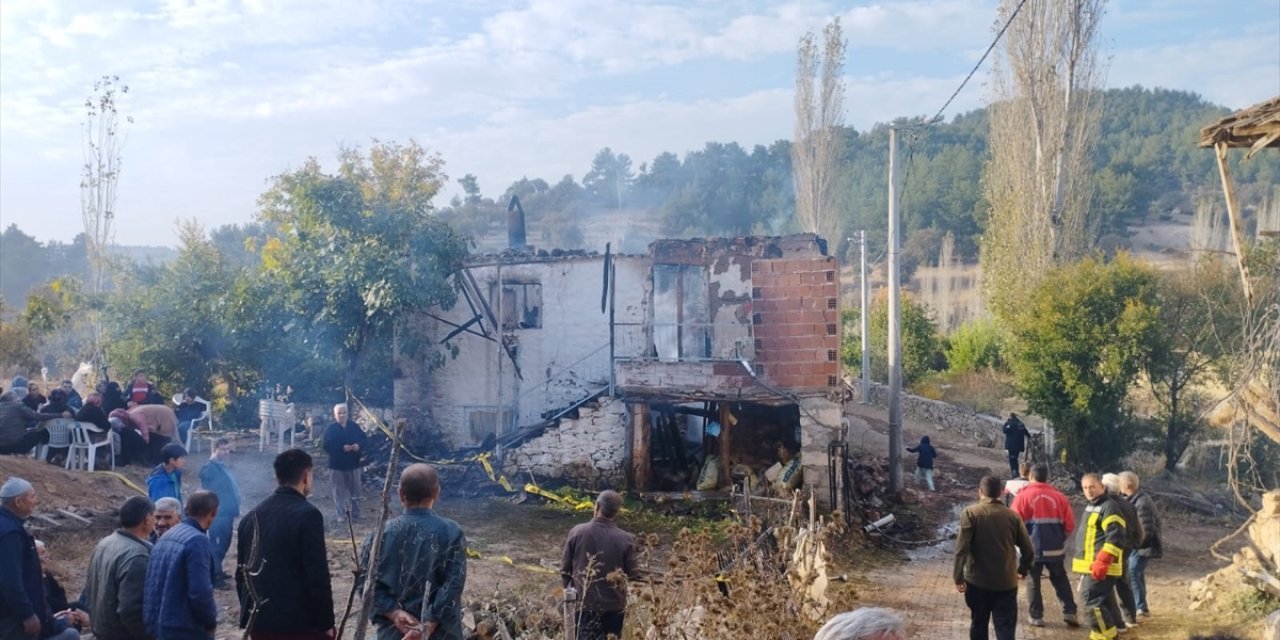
[751,257,840,389]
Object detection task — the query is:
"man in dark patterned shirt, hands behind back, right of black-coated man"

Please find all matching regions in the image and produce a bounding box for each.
[361,463,467,640]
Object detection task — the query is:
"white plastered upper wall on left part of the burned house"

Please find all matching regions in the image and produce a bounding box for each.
[424,256,650,447]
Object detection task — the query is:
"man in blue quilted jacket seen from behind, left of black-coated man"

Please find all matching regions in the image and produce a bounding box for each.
[142,492,218,640]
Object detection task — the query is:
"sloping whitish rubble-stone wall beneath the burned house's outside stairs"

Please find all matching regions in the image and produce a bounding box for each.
[503,397,627,486]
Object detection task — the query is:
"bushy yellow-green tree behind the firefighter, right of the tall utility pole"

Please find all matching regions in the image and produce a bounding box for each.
[1009,252,1160,468]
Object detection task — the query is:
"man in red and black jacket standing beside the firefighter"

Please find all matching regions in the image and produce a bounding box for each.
[1011,463,1080,627]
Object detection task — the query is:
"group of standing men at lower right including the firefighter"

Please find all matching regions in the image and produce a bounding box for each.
[954,462,1164,640]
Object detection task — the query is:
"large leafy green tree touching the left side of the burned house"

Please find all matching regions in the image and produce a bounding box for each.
[259,140,467,389]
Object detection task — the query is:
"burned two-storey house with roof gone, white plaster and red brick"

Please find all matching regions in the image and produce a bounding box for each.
[396,234,841,504]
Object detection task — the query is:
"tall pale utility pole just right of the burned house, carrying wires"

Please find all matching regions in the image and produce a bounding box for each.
[888,127,902,495]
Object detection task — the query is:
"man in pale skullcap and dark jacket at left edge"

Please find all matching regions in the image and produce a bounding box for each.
[0,476,79,640]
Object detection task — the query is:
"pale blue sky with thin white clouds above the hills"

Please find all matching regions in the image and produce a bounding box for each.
[0,0,1280,244]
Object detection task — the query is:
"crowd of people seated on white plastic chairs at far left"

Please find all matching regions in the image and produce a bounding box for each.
[0,369,209,465]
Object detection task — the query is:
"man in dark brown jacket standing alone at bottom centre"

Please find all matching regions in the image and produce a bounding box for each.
[561,490,640,640]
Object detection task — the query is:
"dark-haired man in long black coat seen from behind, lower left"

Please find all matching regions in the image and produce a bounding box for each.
[236,449,334,640]
